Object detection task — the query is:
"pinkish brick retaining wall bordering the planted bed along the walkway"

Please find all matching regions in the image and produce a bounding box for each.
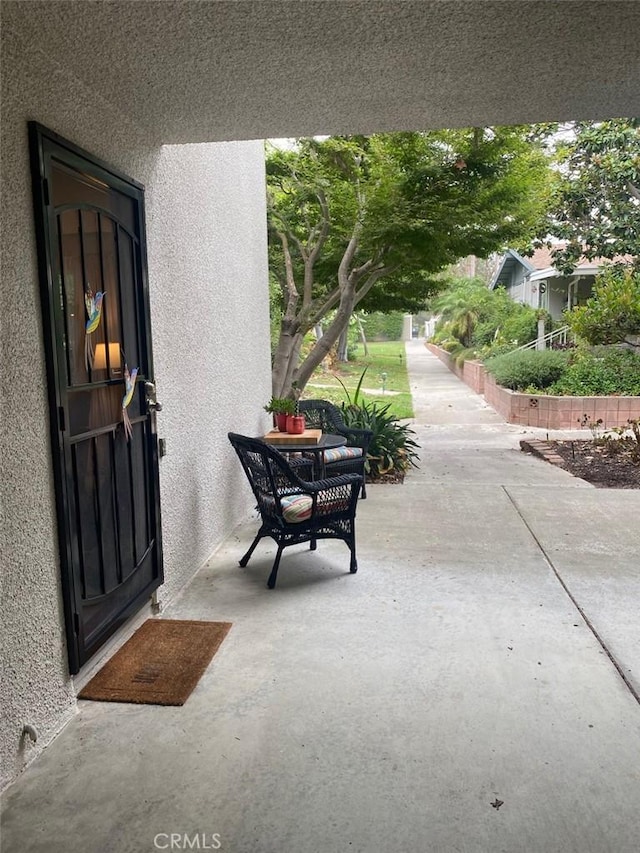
[427,344,640,429]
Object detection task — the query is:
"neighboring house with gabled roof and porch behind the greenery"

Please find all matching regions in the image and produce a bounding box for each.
[489,248,624,320]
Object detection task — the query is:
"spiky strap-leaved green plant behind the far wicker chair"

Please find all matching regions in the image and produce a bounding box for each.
[341,402,419,478]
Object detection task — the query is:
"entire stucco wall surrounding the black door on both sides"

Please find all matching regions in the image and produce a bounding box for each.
[0,26,270,785]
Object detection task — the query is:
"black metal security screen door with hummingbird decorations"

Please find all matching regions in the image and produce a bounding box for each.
[30,124,163,672]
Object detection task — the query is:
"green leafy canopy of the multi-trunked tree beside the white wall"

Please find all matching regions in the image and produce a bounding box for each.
[267,128,548,318]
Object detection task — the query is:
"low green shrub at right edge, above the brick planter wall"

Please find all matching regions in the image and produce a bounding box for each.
[547,347,640,397]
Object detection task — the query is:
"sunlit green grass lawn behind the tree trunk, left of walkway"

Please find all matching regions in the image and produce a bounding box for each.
[302,341,413,418]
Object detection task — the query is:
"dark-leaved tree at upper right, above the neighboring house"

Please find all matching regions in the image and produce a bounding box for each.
[539,118,640,273]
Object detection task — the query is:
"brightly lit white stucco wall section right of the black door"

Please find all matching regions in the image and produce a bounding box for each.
[147,142,271,600]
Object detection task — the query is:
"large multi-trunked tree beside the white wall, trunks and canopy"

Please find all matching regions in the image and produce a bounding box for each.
[267,127,548,397]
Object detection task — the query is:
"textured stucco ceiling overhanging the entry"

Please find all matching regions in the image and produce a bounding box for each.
[2,0,640,142]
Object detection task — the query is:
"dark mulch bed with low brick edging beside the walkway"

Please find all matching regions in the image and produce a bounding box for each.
[520,438,640,489]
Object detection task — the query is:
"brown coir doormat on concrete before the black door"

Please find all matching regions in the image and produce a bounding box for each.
[78,619,231,705]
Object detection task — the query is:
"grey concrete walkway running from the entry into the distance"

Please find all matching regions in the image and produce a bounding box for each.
[2,341,640,853]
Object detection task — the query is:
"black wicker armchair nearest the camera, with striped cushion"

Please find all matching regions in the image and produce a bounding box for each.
[228,432,362,589]
